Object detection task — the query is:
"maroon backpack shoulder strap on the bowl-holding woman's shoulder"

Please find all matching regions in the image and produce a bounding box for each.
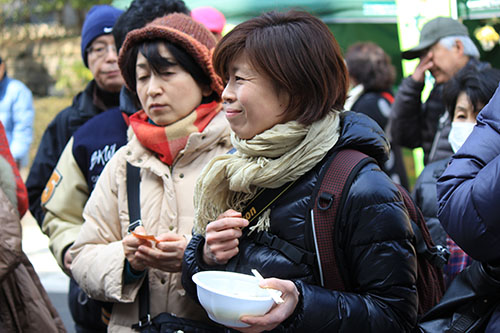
[311,149,374,290]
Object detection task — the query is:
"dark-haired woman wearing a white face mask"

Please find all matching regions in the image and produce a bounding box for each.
[412,68,500,285]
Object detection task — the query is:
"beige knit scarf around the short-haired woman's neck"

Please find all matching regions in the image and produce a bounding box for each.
[194,111,340,235]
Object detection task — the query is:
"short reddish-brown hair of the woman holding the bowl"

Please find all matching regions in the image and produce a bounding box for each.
[213,12,348,125]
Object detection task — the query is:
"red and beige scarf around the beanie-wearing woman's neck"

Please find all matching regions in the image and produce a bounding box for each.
[129,101,221,165]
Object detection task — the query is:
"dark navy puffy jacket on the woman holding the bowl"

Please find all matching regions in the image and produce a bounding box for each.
[182,112,417,332]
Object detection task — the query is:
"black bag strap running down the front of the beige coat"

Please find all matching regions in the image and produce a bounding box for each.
[127,162,151,328]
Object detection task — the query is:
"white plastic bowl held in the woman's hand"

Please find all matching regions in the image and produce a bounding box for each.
[193,271,273,327]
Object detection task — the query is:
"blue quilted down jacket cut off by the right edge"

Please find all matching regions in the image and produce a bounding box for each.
[437,82,500,332]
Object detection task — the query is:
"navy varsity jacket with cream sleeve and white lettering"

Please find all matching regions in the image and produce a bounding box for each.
[41,89,136,267]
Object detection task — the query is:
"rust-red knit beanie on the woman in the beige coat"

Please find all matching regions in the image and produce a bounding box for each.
[118,13,224,101]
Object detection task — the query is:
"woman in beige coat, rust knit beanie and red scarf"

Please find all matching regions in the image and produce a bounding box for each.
[70,13,231,332]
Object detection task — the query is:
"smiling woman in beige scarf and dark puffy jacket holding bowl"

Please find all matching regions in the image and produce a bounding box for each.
[182,11,417,332]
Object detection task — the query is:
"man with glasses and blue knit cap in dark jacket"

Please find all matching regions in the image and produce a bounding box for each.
[26,5,124,226]
